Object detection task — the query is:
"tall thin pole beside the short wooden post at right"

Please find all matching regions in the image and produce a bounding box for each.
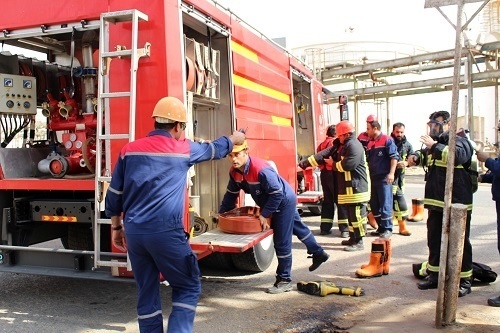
[435,0,464,328]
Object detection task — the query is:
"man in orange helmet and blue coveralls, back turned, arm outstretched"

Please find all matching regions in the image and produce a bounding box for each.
[106,97,245,333]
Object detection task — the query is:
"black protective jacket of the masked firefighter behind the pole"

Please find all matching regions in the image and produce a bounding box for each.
[414,132,474,211]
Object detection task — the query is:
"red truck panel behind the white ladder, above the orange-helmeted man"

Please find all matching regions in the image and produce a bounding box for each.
[102,0,184,169]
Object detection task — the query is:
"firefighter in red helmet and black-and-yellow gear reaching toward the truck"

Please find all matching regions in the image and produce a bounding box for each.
[299,120,370,251]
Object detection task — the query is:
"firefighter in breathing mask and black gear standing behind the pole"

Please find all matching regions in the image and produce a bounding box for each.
[408,111,474,297]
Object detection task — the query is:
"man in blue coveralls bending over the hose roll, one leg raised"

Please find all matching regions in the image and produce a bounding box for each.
[219,140,329,294]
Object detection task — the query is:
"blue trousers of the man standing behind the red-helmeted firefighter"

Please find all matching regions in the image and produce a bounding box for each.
[370,178,392,232]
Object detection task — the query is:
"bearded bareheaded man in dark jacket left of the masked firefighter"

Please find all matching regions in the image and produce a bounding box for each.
[391,123,413,236]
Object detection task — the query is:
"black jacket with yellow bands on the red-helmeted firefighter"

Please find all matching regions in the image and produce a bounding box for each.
[333,136,370,205]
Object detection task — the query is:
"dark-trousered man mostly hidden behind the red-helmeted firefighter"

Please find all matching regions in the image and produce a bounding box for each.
[316,125,349,237]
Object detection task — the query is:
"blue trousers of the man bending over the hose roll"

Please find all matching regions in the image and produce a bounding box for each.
[272,201,323,279]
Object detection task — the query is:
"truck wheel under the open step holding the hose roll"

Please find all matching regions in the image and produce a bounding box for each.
[231,235,274,272]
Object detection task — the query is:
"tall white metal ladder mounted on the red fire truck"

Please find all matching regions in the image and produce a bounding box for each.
[93,9,150,275]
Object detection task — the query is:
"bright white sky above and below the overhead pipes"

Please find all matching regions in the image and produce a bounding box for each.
[217,0,496,148]
